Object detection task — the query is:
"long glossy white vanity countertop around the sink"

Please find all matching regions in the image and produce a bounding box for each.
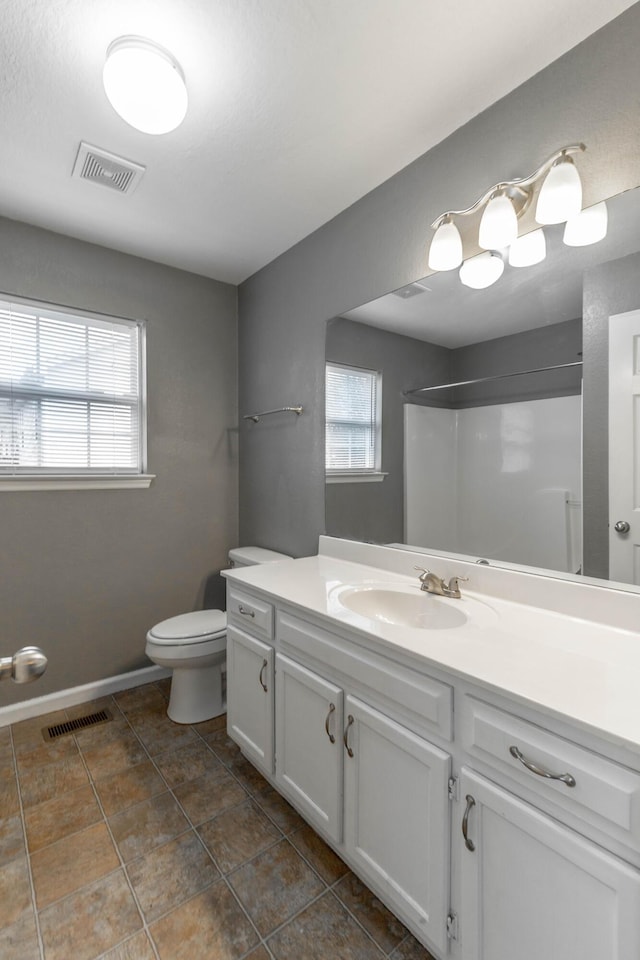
[225,538,640,753]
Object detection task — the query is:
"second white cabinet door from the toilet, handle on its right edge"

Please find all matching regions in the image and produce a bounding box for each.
[276,654,343,843]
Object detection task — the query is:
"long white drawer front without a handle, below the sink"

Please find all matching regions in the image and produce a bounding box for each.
[277,612,453,740]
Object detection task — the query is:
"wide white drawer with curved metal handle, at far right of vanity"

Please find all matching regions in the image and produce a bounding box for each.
[462,696,640,849]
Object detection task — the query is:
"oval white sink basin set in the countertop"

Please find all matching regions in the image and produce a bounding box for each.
[339,587,467,630]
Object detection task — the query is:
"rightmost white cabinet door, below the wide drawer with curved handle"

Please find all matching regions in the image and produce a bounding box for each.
[454,769,640,960]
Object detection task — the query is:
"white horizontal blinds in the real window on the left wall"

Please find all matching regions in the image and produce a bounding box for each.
[0,300,143,475]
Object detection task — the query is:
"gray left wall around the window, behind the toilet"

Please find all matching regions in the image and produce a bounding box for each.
[0,219,238,705]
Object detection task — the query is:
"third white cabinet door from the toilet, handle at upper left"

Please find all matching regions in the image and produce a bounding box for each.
[344,696,451,952]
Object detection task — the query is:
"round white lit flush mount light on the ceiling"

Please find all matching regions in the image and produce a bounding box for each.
[102,36,188,134]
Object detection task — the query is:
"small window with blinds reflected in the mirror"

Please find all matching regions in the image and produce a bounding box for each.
[325,363,384,483]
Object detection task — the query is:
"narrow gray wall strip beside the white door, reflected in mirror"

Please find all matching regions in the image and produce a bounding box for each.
[582,253,640,577]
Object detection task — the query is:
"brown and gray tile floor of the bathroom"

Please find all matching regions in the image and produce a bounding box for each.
[0,681,433,960]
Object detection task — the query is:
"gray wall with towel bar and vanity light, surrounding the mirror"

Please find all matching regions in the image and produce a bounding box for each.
[239,4,640,556]
